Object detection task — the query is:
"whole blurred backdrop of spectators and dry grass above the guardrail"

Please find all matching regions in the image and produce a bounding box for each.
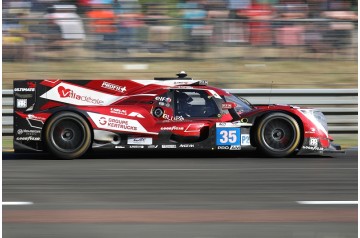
[2,0,358,88]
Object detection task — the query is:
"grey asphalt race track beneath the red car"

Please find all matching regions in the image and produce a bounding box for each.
[2,149,358,238]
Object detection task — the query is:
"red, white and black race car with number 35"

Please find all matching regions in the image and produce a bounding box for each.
[14,72,341,159]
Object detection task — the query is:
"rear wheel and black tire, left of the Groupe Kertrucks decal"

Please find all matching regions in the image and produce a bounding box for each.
[44,112,92,159]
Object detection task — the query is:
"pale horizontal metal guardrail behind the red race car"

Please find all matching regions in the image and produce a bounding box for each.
[2,89,358,136]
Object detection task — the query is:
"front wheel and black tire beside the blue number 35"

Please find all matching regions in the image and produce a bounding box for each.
[256,112,301,158]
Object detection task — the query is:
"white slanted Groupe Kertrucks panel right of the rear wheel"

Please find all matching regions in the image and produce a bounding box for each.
[88,112,153,134]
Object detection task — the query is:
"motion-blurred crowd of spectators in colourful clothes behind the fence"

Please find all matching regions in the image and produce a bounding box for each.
[2,0,358,61]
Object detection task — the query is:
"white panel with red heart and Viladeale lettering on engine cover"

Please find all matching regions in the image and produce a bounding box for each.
[40,82,122,105]
